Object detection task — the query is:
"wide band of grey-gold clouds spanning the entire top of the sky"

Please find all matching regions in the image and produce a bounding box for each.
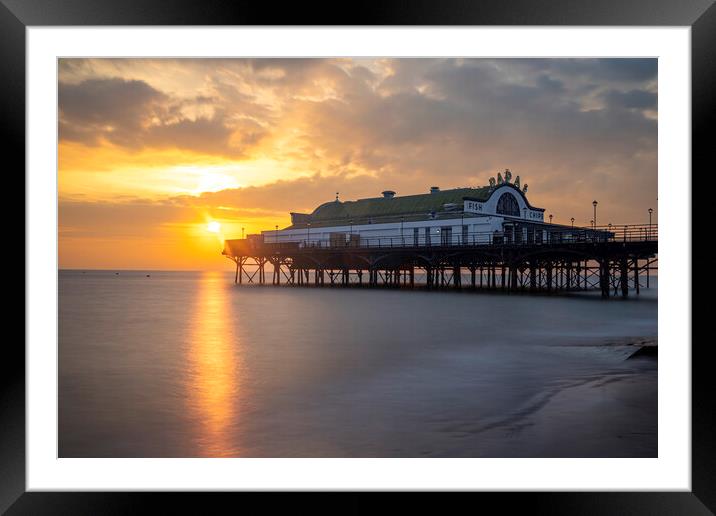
[60,59,656,175]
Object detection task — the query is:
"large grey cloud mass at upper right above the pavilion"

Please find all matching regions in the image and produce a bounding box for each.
[266,56,656,198]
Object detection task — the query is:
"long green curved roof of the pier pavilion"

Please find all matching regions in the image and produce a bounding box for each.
[291,185,501,228]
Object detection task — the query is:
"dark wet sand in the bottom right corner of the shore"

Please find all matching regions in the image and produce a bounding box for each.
[448,338,658,457]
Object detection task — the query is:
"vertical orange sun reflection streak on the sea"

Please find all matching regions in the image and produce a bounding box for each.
[187,272,240,457]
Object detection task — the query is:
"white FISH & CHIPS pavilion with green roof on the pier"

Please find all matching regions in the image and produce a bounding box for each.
[262,175,580,247]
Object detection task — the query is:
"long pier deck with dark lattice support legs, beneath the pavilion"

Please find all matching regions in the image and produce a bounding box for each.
[222,224,658,298]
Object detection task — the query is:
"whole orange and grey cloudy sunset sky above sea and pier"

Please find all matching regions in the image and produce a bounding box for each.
[58,58,658,270]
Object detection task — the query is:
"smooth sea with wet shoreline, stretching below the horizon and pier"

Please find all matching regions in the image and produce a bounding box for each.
[59,271,657,457]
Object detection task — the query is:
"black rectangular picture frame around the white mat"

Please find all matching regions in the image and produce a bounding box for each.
[0,0,716,515]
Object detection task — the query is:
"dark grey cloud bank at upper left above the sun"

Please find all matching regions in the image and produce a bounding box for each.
[59,77,264,158]
